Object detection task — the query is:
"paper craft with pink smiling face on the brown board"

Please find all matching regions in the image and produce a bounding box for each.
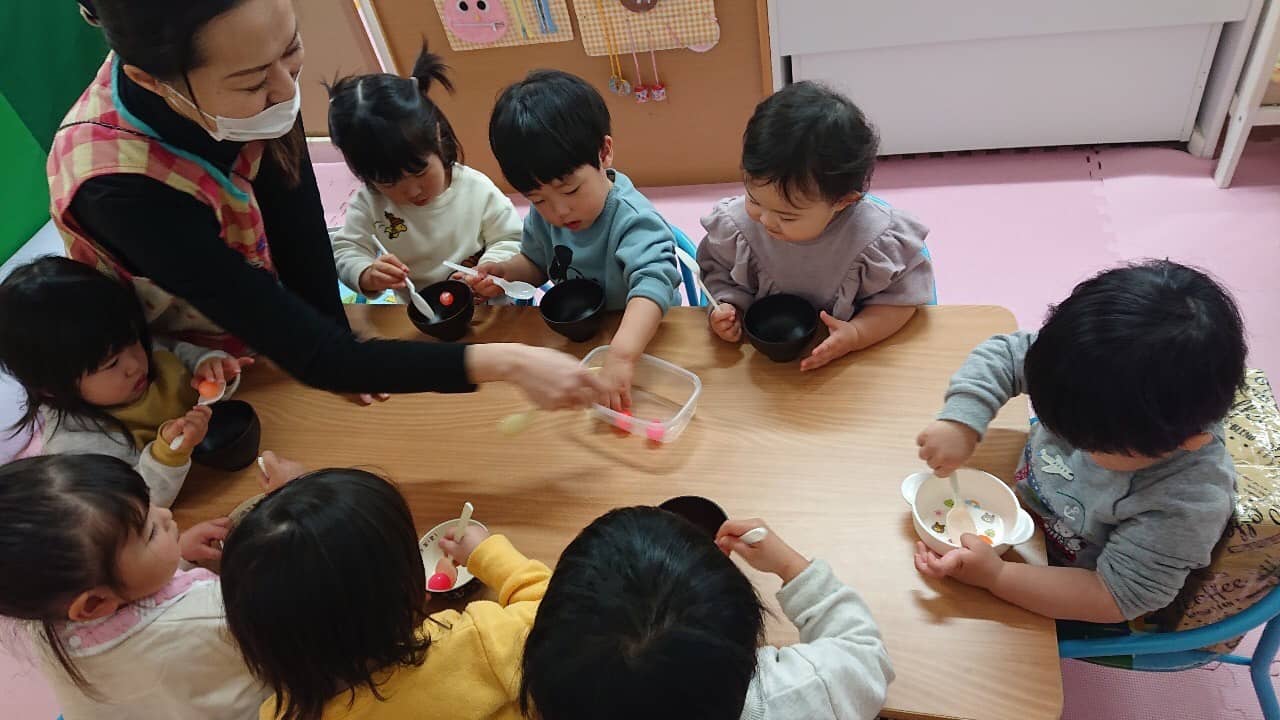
[435,0,573,50]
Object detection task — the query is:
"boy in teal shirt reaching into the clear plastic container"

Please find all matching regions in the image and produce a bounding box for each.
[475,70,680,410]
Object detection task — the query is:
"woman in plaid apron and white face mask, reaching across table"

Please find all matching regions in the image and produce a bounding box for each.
[49,0,598,407]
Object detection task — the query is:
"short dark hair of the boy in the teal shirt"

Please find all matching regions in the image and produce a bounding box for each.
[489,70,611,193]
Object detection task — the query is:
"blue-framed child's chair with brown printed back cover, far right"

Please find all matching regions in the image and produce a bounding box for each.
[1057,370,1280,720]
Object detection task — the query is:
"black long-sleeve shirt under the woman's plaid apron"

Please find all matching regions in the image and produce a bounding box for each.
[70,65,474,392]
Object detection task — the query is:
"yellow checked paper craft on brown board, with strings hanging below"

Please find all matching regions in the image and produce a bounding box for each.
[573,0,719,59]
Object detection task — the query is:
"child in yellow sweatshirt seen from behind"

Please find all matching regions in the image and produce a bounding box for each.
[223,469,550,720]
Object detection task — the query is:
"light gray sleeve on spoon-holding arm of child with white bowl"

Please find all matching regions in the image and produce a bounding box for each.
[938,332,1036,437]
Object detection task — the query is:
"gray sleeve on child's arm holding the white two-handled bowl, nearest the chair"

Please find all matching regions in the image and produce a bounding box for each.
[1097,460,1234,620]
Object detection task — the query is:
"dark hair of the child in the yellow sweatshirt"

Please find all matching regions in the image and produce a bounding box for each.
[221,469,429,720]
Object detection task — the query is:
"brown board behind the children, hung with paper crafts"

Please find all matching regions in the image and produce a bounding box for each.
[372,0,773,190]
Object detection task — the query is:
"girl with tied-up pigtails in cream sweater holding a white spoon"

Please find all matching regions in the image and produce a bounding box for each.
[329,47,521,300]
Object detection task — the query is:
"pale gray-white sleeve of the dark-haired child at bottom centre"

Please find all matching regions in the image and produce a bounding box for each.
[751,560,893,720]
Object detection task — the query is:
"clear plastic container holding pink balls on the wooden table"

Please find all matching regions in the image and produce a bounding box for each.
[582,345,703,442]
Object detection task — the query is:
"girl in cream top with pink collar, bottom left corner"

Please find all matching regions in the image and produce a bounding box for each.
[0,455,291,720]
